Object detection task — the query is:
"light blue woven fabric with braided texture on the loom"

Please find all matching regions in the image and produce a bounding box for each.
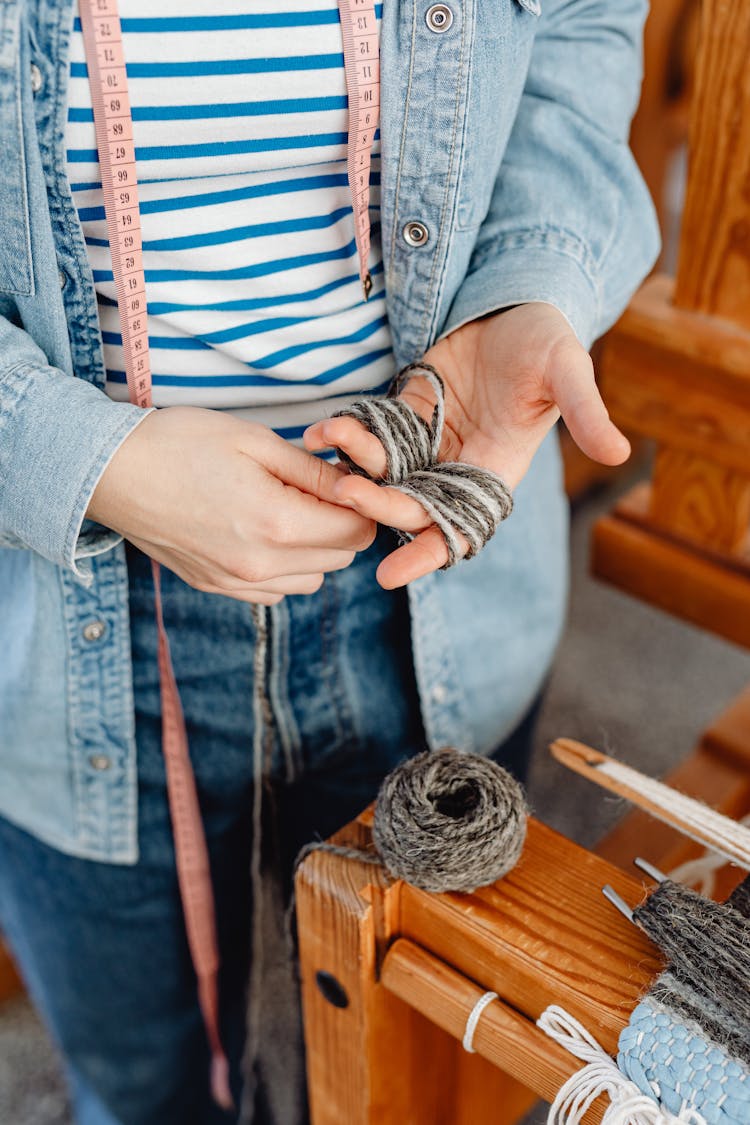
[617,998,750,1125]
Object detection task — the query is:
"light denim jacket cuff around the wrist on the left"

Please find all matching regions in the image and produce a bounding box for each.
[0,365,151,584]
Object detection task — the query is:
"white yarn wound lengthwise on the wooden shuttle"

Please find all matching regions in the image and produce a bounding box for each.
[596,758,750,871]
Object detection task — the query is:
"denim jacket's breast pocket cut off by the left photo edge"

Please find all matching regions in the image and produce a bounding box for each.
[0,2,34,297]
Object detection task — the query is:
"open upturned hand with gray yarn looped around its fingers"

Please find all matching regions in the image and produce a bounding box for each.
[305,303,630,590]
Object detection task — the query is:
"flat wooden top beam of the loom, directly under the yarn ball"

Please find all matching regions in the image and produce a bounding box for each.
[399,820,660,1053]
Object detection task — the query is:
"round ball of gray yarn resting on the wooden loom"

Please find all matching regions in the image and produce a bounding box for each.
[372,749,528,892]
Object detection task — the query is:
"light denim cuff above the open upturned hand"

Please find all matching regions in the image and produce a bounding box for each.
[440,236,599,351]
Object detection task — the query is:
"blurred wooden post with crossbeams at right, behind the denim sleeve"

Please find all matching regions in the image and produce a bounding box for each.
[594,0,750,646]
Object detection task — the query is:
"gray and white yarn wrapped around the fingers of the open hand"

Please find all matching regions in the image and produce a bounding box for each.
[334,363,513,570]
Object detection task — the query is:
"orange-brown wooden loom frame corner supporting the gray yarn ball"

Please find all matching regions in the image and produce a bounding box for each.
[296,812,659,1125]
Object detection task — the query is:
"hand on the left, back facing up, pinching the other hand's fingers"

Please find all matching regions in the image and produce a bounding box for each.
[87,406,376,605]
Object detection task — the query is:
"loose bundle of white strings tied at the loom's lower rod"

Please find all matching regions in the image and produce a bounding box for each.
[536,1005,706,1125]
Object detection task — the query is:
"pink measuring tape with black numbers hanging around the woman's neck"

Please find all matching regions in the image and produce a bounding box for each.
[80,0,380,1108]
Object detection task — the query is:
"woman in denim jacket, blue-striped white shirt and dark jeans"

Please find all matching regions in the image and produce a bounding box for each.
[0,0,657,1125]
